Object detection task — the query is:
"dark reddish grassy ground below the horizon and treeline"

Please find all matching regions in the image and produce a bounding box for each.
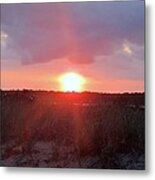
[0,90,145,169]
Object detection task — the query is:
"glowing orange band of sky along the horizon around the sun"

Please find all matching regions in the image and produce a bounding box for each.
[1,56,144,92]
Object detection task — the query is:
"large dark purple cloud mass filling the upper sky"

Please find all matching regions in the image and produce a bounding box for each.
[1,1,144,64]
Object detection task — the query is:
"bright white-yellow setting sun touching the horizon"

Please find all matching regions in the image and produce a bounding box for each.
[60,72,85,92]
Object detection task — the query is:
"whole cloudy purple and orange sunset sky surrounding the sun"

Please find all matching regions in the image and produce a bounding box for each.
[0,0,144,93]
